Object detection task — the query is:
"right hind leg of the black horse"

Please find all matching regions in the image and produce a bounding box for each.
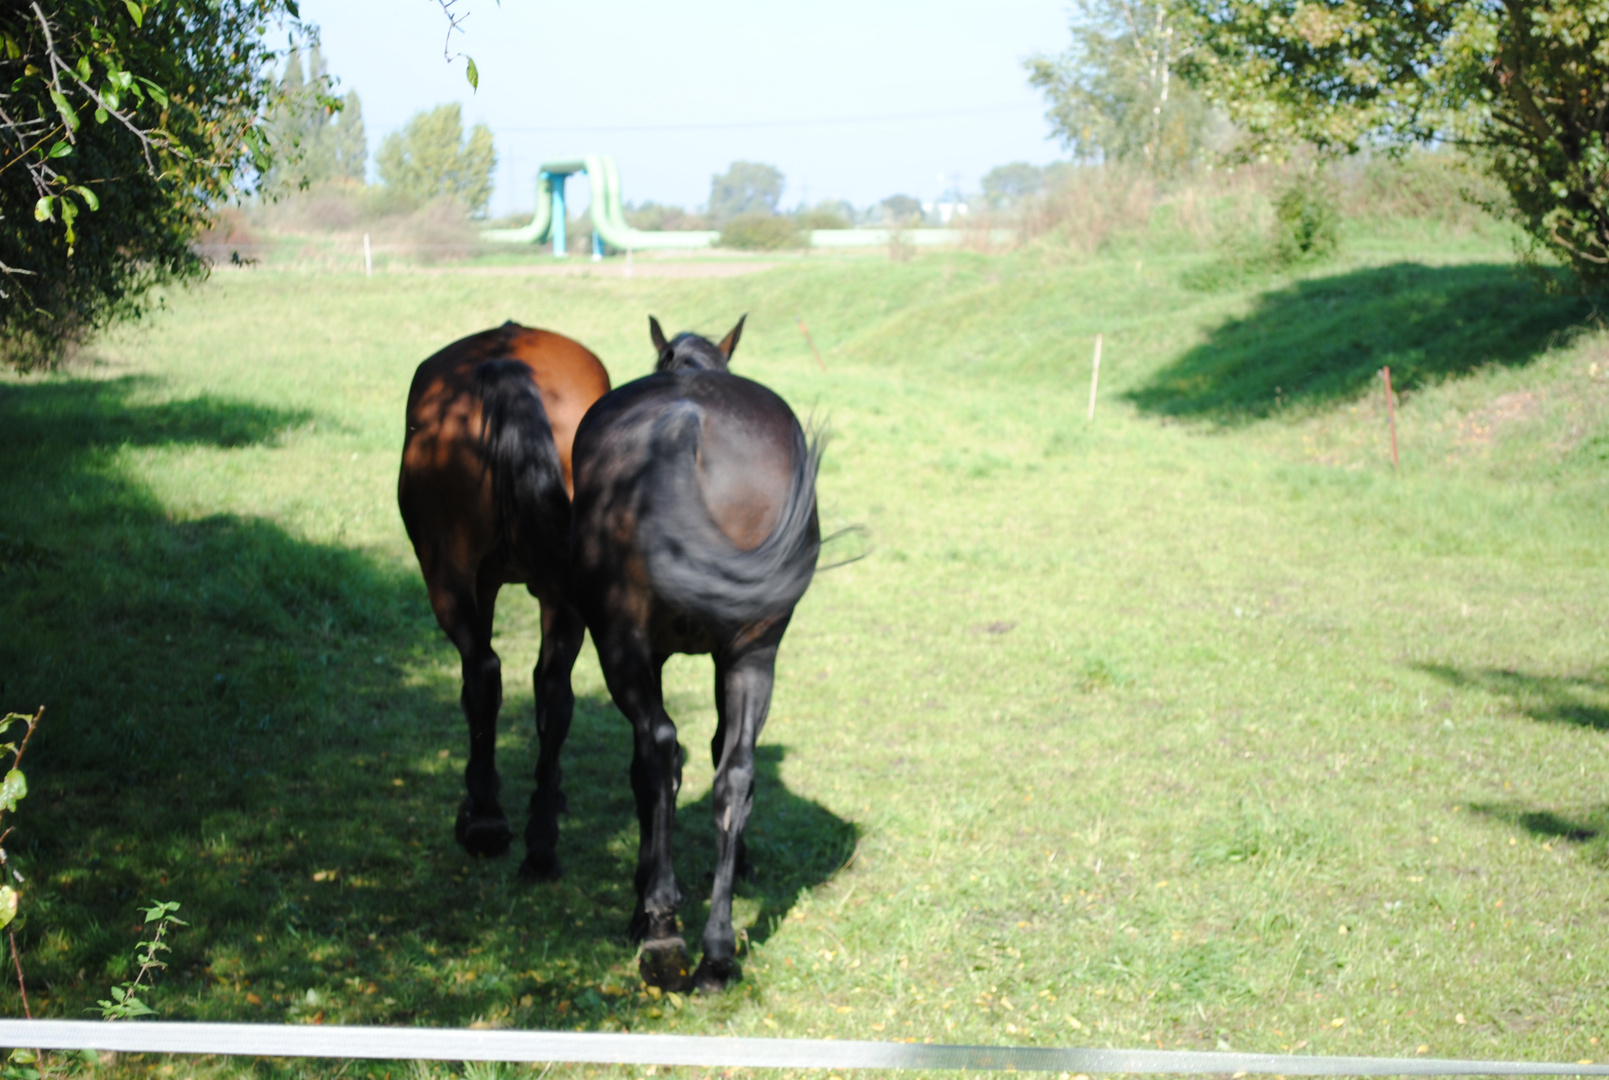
[693,645,777,993]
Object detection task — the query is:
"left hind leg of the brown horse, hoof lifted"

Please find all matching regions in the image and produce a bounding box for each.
[431,569,513,856]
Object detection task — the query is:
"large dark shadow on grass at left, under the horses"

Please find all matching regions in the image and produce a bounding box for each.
[0,378,854,1036]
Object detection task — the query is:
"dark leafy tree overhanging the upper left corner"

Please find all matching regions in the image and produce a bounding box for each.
[0,0,311,369]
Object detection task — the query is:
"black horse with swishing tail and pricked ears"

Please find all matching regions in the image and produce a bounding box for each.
[571,310,821,990]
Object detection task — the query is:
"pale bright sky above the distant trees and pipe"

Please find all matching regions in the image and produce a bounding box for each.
[301,0,1068,216]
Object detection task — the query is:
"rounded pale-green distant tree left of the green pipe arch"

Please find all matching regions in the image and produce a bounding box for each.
[375,103,497,214]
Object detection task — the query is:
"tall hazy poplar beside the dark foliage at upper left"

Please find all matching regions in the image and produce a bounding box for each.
[262,45,368,193]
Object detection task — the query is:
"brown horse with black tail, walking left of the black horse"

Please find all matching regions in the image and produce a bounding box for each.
[397,322,608,877]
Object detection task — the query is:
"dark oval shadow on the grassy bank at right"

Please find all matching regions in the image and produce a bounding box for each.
[1128,262,1591,423]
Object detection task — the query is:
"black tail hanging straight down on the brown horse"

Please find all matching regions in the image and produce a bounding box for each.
[475,361,570,567]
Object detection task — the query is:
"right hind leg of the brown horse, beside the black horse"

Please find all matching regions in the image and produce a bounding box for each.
[520,604,586,880]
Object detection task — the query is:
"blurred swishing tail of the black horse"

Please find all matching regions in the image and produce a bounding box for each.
[639,402,821,626]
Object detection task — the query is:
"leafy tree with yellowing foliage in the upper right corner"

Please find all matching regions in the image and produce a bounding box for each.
[1184,0,1609,285]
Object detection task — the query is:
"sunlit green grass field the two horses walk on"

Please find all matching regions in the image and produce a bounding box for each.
[0,214,1609,1080]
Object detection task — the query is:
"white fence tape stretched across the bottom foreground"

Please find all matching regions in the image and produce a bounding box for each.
[0,1020,1609,1077]
